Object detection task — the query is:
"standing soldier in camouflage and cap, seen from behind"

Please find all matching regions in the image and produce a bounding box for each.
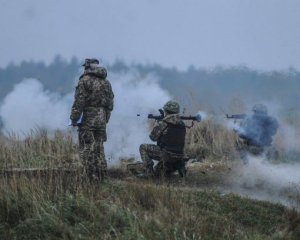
[70,59,114,181]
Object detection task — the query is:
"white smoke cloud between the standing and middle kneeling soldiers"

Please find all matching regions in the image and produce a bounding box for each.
[105,73,170,163]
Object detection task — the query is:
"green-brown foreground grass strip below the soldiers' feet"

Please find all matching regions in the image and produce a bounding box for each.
[0,175,300,239]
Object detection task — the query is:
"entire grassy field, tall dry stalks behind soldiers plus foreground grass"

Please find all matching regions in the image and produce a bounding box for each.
[0,121,300,239]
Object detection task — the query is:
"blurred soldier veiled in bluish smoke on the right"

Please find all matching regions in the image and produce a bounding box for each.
[236,104,278,155]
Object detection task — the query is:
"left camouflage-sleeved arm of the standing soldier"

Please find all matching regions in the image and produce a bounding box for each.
[70,79,87,123]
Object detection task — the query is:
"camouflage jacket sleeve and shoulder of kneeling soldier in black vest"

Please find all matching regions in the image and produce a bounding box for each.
[149,114,184,142]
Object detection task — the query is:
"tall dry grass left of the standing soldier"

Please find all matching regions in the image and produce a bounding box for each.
[0,129,79,169]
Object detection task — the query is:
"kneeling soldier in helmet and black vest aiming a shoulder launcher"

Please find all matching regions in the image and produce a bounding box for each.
[140,101,186,176]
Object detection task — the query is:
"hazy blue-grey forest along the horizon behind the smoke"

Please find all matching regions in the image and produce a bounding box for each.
[0,56,300,110]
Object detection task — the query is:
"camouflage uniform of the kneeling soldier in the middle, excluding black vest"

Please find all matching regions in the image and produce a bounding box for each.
[139,101,185,173]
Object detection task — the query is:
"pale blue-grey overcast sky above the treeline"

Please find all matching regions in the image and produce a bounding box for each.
[0,0,300,70]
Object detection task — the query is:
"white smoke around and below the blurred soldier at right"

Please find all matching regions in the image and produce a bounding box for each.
[222,101,300,209]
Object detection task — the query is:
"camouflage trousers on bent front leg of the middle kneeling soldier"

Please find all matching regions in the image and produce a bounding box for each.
[140,144,162,169]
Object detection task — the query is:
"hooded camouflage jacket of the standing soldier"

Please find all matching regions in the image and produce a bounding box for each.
[70,68,114,136]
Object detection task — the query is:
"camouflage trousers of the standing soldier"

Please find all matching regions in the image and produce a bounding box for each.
[78,129,107,180]
